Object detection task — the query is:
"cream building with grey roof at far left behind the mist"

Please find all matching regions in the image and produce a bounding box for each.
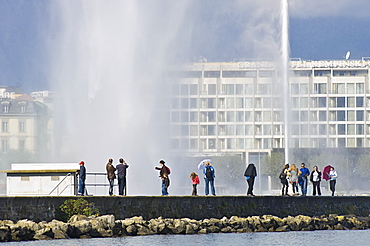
[0,86,51,154]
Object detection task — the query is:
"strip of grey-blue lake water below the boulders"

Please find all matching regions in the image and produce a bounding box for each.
[1,230,370,246]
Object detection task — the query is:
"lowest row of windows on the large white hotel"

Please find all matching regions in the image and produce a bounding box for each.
[171,138,370,150]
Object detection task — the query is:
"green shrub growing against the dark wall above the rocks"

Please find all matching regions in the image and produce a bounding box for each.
[59,198,99,219]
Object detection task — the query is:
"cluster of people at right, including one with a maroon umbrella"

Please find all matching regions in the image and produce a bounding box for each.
[279,163,338,196]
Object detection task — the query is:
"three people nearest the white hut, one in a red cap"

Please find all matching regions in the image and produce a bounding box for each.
[77,158,129,196]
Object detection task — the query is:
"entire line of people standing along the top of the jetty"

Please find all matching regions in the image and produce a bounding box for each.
[77,158,338,196]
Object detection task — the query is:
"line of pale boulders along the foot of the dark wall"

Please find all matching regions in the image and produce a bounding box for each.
[0,214,370,242]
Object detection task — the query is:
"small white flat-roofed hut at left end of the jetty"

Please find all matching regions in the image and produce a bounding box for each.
[1,163,80,196]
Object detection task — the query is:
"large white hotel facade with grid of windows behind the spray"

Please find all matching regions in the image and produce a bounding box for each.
[167,58,370,161]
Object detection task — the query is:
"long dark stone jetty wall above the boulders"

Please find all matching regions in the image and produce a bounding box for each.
[0,196,370,222]
